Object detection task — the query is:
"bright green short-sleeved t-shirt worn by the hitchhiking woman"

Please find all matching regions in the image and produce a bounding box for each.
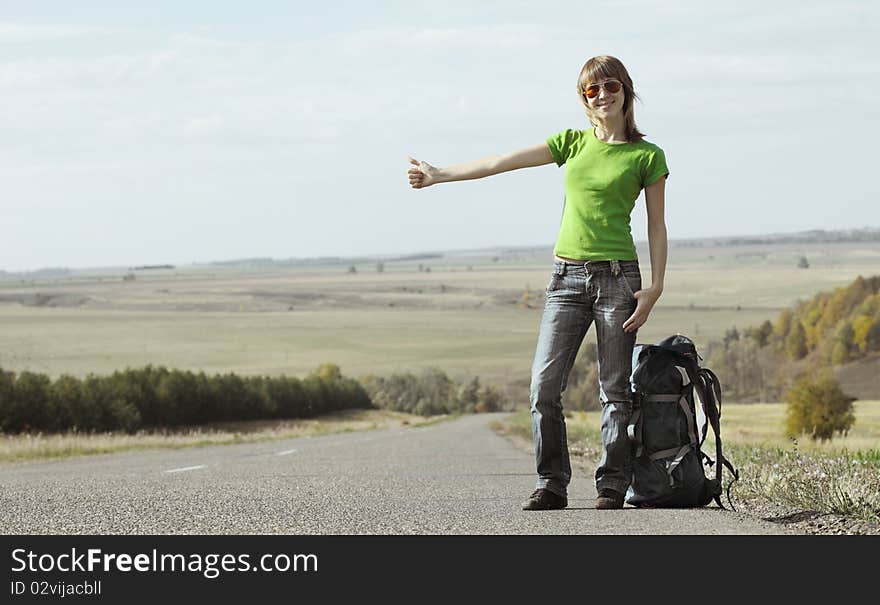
[547,128,669,260]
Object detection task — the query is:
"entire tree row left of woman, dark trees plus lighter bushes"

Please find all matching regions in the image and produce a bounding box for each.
[0,363,509,433]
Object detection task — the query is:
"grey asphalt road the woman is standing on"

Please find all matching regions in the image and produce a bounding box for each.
[0,415,787,534]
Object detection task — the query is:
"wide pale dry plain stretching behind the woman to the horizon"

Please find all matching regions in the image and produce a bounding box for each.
[0,238,880,394]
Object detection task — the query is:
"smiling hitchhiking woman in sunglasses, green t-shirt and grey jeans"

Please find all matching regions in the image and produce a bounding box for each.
[409,55,669,510]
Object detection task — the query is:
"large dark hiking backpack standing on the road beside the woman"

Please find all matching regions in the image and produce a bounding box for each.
[626,334,739,510]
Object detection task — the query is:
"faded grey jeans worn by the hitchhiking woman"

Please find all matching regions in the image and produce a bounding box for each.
[531,260,642,496]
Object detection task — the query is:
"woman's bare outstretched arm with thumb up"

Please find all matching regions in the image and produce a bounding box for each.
[408,143,554,189]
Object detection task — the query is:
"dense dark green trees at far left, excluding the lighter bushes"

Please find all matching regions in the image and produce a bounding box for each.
[0,364,372,433]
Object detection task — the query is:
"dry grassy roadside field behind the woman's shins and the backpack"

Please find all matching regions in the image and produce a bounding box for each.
[493,401,880,523]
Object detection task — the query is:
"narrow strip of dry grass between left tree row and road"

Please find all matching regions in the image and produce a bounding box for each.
[0,410,445,462]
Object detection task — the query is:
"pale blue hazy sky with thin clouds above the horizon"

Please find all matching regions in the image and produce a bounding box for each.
[0,0,880,271]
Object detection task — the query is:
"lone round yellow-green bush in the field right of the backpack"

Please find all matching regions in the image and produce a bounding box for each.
[784,368,855,441]
